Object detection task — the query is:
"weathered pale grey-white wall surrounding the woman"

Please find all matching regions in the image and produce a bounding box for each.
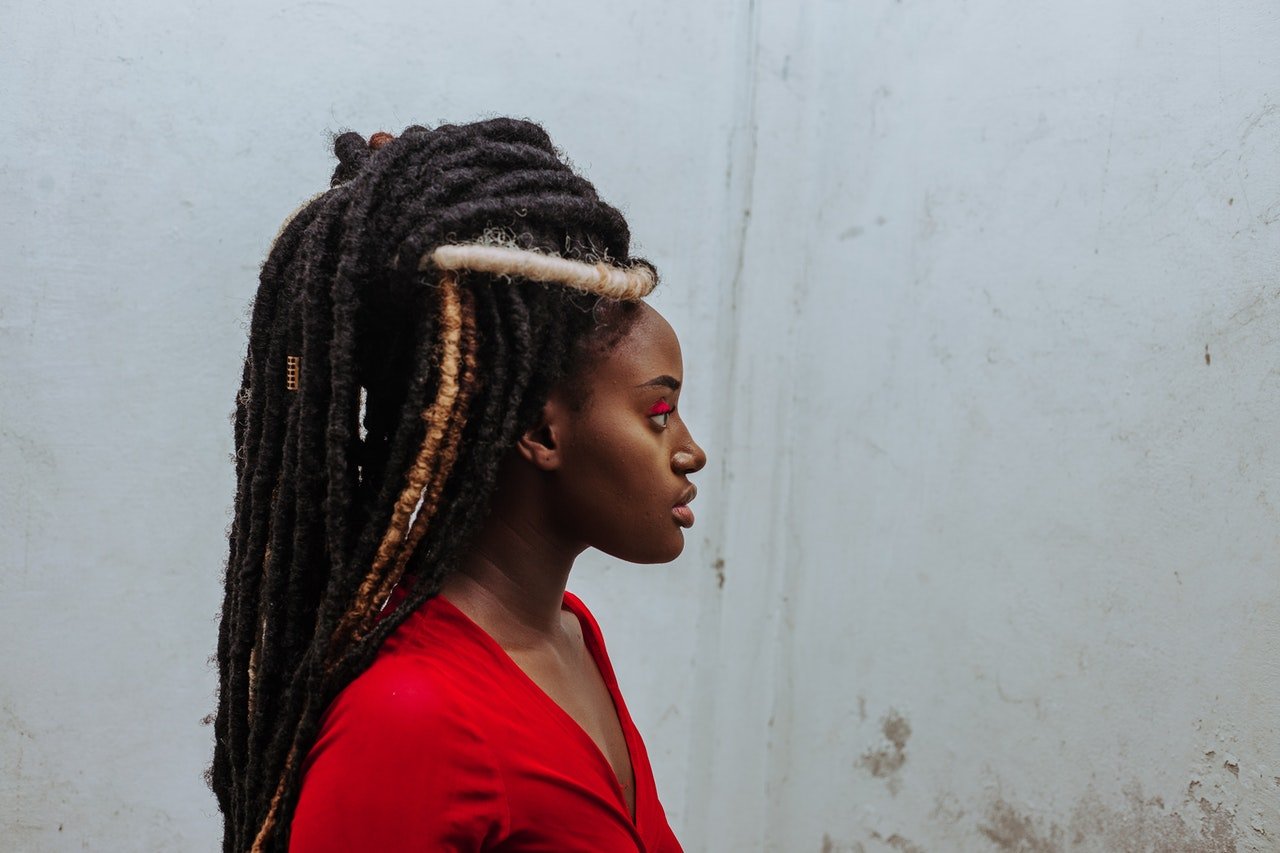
[0,0,1280,853]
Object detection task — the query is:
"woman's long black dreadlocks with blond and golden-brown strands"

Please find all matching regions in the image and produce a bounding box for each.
[210,119,654,853]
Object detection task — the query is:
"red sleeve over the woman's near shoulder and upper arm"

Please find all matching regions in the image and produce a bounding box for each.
[289,671,509,853]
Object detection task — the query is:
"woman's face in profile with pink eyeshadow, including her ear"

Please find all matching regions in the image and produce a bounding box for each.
[518,304,707,562]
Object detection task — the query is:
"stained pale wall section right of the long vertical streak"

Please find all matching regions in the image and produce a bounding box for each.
[721,0,1280,850]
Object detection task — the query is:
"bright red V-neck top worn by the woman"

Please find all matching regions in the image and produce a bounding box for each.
[289,593,681,853]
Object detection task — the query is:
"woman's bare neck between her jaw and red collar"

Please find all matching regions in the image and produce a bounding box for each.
[440,466,584,649]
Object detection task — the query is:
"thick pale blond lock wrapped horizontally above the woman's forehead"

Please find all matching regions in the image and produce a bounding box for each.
[419,243,658,300]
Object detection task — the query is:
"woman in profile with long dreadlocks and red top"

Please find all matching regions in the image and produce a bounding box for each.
[211,119,705,852]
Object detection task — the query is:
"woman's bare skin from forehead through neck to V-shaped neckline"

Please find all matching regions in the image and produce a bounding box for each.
[442,305,707,818]
